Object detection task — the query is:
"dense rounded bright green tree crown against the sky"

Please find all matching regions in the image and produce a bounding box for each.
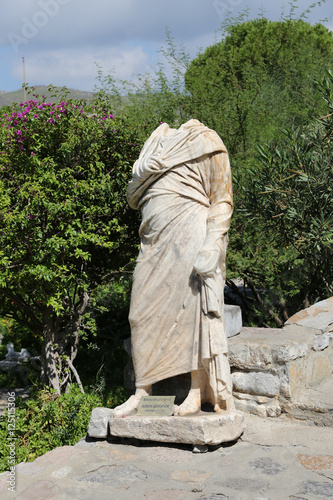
[185,18,333,162]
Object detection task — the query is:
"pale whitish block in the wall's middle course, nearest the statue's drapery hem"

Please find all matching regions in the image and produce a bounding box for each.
[232,372,280,397]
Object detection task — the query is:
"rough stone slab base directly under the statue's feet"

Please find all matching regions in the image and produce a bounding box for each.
[109,410,245,445]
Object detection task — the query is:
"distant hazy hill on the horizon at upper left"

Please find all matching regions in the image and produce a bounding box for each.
[0,85,94,107]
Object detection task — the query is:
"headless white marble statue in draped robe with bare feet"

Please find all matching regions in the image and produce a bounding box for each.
[113,120,234,418]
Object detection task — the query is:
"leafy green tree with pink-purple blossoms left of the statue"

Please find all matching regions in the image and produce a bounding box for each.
[0,90,140,393]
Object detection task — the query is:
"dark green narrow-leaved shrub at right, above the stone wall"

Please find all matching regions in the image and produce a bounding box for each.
[231,71,333,312]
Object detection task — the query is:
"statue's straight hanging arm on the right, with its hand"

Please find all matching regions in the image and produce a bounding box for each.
[194,152,233,276]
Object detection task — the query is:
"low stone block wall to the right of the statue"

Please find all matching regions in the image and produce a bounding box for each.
[229,298,333,417]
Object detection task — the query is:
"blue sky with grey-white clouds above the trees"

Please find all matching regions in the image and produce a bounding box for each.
[0,0,333,91]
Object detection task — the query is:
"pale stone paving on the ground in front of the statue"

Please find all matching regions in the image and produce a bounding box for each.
[0,415,333,500]
